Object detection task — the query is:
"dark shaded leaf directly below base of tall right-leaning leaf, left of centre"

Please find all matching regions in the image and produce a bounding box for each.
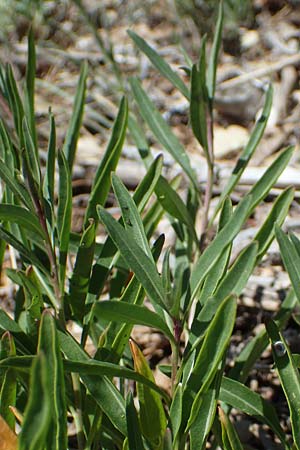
[69,219,96,321]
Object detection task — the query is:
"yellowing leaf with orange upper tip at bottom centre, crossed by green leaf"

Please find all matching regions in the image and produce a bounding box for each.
[130,341,167,449]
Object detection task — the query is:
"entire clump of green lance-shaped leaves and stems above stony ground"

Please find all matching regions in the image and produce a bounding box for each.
[0,4,300,450]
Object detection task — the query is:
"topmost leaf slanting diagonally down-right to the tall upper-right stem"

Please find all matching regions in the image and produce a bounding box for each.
[127,30,189,99]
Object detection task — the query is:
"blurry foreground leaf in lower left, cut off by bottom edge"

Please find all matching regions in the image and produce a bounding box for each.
[18,353,51,450]
